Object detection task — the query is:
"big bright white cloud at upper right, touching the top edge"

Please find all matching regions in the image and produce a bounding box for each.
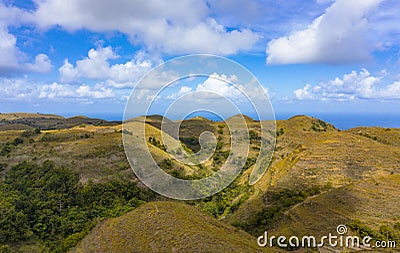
[266,0,382,64]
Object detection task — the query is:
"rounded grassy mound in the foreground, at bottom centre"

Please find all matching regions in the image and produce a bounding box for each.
[72,202,276,253]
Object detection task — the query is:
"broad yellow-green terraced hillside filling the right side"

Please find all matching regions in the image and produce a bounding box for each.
[227,116,400,244]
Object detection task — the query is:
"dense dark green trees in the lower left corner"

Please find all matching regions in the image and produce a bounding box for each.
[0,161,154,252]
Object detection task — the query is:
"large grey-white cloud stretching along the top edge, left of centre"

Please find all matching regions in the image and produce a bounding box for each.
[34,0,260,55]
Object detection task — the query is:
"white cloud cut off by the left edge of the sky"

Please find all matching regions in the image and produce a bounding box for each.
[0,21,52,76]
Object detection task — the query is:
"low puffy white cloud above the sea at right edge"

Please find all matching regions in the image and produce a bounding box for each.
[294,69,400,101]
